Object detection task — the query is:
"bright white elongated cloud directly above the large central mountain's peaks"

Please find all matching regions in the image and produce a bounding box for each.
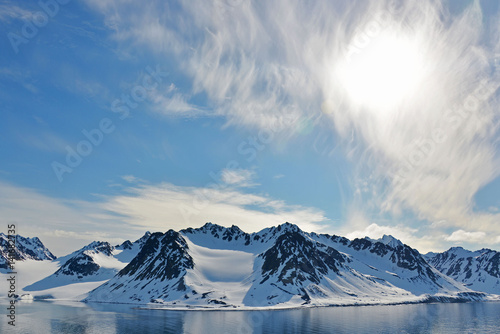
[102,183,327,232]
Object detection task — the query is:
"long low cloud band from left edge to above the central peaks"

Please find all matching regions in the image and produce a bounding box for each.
[0,180,328,256]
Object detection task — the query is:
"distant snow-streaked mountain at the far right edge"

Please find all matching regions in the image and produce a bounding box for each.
[425,247,500,294]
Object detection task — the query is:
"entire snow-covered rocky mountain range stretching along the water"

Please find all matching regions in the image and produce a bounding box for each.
[0,223,500,308]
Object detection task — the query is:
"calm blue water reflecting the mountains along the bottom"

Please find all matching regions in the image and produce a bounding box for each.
[0,300,500,334]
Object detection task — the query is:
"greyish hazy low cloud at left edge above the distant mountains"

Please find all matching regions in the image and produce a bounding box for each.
[0,181,129,256]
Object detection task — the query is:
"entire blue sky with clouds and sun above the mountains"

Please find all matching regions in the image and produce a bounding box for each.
[0,0,500,256]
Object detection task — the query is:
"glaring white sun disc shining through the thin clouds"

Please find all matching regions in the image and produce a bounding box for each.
[336,33,425,112]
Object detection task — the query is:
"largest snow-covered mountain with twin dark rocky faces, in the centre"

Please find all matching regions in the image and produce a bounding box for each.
[85,223,486,308]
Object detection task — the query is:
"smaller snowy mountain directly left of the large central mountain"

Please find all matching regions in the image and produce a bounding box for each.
[24,232,151,291]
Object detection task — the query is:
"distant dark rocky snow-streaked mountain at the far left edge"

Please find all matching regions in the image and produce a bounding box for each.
[0,233,56,269]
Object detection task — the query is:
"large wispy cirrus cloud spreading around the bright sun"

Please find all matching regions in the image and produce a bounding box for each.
[84,0,500,245]
